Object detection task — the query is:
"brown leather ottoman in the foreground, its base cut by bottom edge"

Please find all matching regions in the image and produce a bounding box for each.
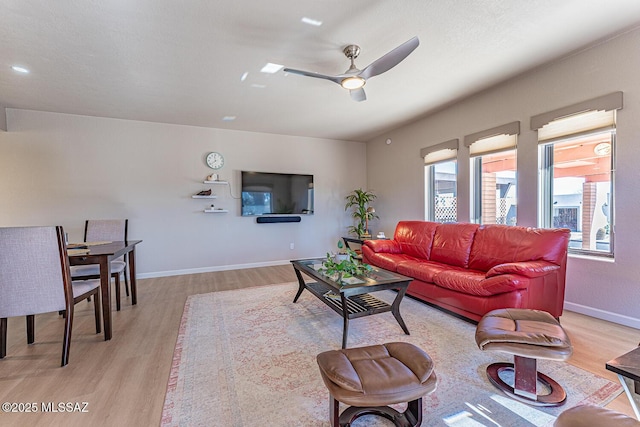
[317,342,437,427]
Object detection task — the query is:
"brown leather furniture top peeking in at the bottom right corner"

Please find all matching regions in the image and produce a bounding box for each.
[553,405,640,427]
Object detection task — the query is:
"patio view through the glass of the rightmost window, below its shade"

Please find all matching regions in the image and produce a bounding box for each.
[541,130,614,253]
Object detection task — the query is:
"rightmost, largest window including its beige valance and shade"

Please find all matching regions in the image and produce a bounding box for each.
[531,92,622,257]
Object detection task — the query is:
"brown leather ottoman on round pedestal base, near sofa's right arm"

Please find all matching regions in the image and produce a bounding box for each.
[476,308,573,406]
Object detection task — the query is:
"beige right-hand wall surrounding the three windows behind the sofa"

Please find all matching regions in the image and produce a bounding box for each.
[367,30,640,328]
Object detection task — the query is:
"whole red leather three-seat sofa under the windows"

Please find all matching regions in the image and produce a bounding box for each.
[362,221,570,321]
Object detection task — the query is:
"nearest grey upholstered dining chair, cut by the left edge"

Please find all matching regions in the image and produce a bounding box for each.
[0,227,100,366]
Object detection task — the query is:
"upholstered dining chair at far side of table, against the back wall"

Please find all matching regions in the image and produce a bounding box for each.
[71,219,129,311]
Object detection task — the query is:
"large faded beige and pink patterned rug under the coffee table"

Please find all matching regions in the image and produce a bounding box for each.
[161,283,622,427]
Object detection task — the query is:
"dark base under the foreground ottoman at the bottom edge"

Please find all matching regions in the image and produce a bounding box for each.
[330,396,422,427]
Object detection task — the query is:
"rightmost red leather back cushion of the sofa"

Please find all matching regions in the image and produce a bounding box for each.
[469,225,570,271]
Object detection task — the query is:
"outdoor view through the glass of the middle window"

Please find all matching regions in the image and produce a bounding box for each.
[471,150,517,225]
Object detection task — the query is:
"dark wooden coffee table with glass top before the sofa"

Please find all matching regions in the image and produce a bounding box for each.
[291,258,413,348]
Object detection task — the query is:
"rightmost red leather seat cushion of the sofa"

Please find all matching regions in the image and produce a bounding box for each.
[433,269,529,296]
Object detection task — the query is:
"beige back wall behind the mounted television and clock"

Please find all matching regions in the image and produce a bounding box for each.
[0,109,366,277]
